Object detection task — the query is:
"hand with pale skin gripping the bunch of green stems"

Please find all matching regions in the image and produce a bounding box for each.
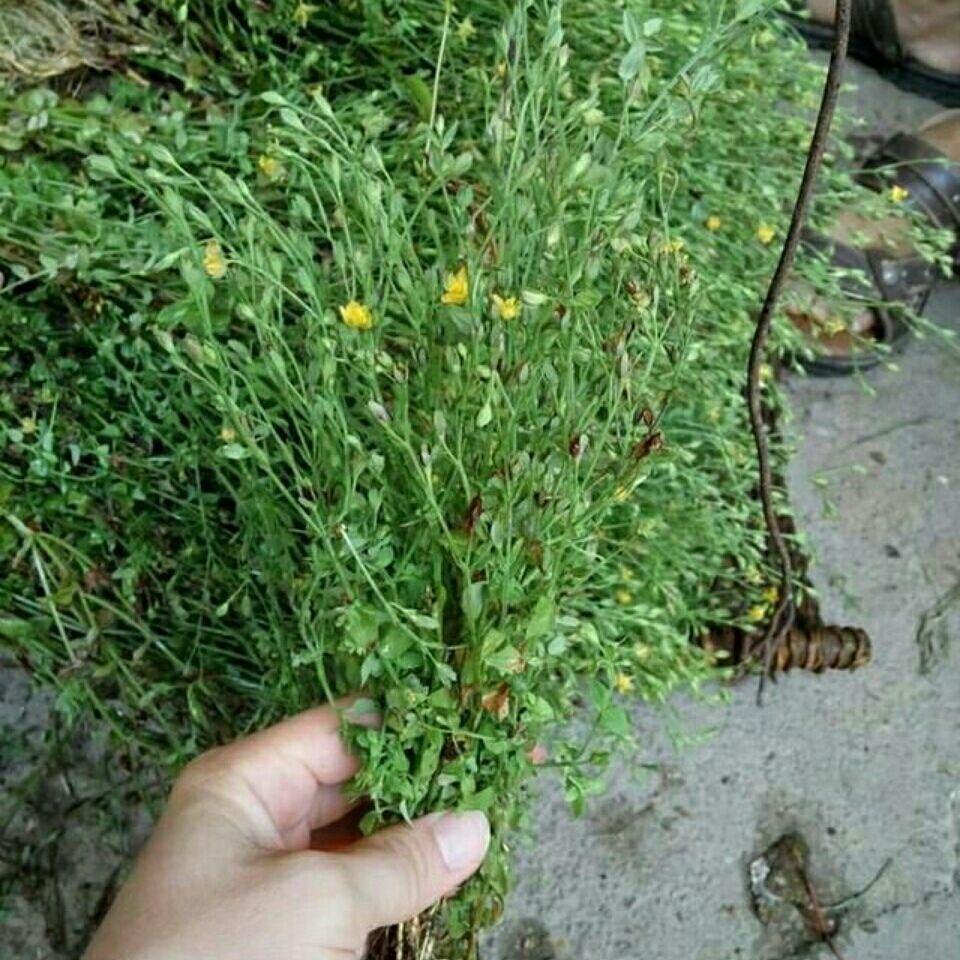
[84,704,490,960]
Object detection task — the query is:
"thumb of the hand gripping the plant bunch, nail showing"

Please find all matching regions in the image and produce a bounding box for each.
[340,811,490,932]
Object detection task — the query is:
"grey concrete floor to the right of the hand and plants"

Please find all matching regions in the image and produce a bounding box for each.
[485,65,960,960]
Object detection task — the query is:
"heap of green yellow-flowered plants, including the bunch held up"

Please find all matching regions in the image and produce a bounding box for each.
[0,0,932,952]
